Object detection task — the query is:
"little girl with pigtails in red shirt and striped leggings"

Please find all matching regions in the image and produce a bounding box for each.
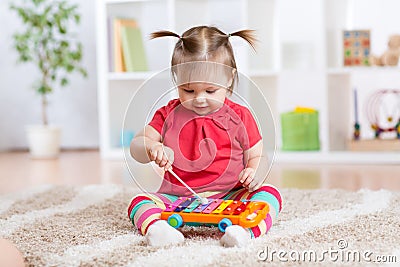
[128,26,282,247]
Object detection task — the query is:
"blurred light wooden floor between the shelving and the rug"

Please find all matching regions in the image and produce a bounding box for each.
[0,150,400,194]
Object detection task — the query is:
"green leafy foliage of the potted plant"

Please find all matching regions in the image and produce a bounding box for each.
[9,0,87,95]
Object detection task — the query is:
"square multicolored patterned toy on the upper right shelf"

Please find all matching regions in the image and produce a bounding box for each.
[343,30,370,66]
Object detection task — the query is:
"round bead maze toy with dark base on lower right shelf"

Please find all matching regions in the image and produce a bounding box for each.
[366,89,400,139]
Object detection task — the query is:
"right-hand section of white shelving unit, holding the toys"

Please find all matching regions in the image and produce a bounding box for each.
[324,0,400,164]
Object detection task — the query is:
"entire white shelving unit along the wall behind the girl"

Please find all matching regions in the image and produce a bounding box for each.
[97,0,400,164]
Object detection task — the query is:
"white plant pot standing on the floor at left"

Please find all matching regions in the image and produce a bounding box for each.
[26,125,61,159]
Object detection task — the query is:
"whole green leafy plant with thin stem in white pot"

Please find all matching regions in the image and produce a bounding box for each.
[10,0,87,158]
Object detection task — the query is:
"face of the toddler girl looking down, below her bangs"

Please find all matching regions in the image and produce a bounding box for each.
[178,82,228,115]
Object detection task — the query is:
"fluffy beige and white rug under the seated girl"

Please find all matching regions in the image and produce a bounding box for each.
[0,184,400,266]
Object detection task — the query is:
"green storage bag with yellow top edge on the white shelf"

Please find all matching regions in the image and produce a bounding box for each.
[281,109,319,151]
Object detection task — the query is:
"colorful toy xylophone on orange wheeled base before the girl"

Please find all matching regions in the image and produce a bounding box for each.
[161,197,269,232]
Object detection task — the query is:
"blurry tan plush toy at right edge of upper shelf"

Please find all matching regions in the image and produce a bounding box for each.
[370,35,400,66]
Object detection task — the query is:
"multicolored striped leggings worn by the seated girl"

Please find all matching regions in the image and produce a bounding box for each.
[128,185,282,238]
